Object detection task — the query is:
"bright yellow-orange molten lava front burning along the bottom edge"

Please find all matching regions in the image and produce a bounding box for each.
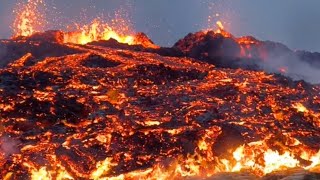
[25,134,320,180]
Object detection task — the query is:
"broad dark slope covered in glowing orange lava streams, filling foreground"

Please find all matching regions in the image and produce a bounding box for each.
[0,38,320,179]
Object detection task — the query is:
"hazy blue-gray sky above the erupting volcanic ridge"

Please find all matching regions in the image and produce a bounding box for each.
[0,0,320,52]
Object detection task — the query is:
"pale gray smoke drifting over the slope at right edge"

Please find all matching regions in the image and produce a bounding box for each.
[210,38,320,84]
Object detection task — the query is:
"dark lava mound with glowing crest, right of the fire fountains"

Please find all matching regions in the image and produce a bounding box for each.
[174,30,293,67]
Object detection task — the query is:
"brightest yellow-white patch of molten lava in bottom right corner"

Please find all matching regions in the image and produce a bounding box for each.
[215,135,319,176]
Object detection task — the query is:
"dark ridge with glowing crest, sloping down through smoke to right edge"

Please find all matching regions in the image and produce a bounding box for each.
[173,30,320,84]
